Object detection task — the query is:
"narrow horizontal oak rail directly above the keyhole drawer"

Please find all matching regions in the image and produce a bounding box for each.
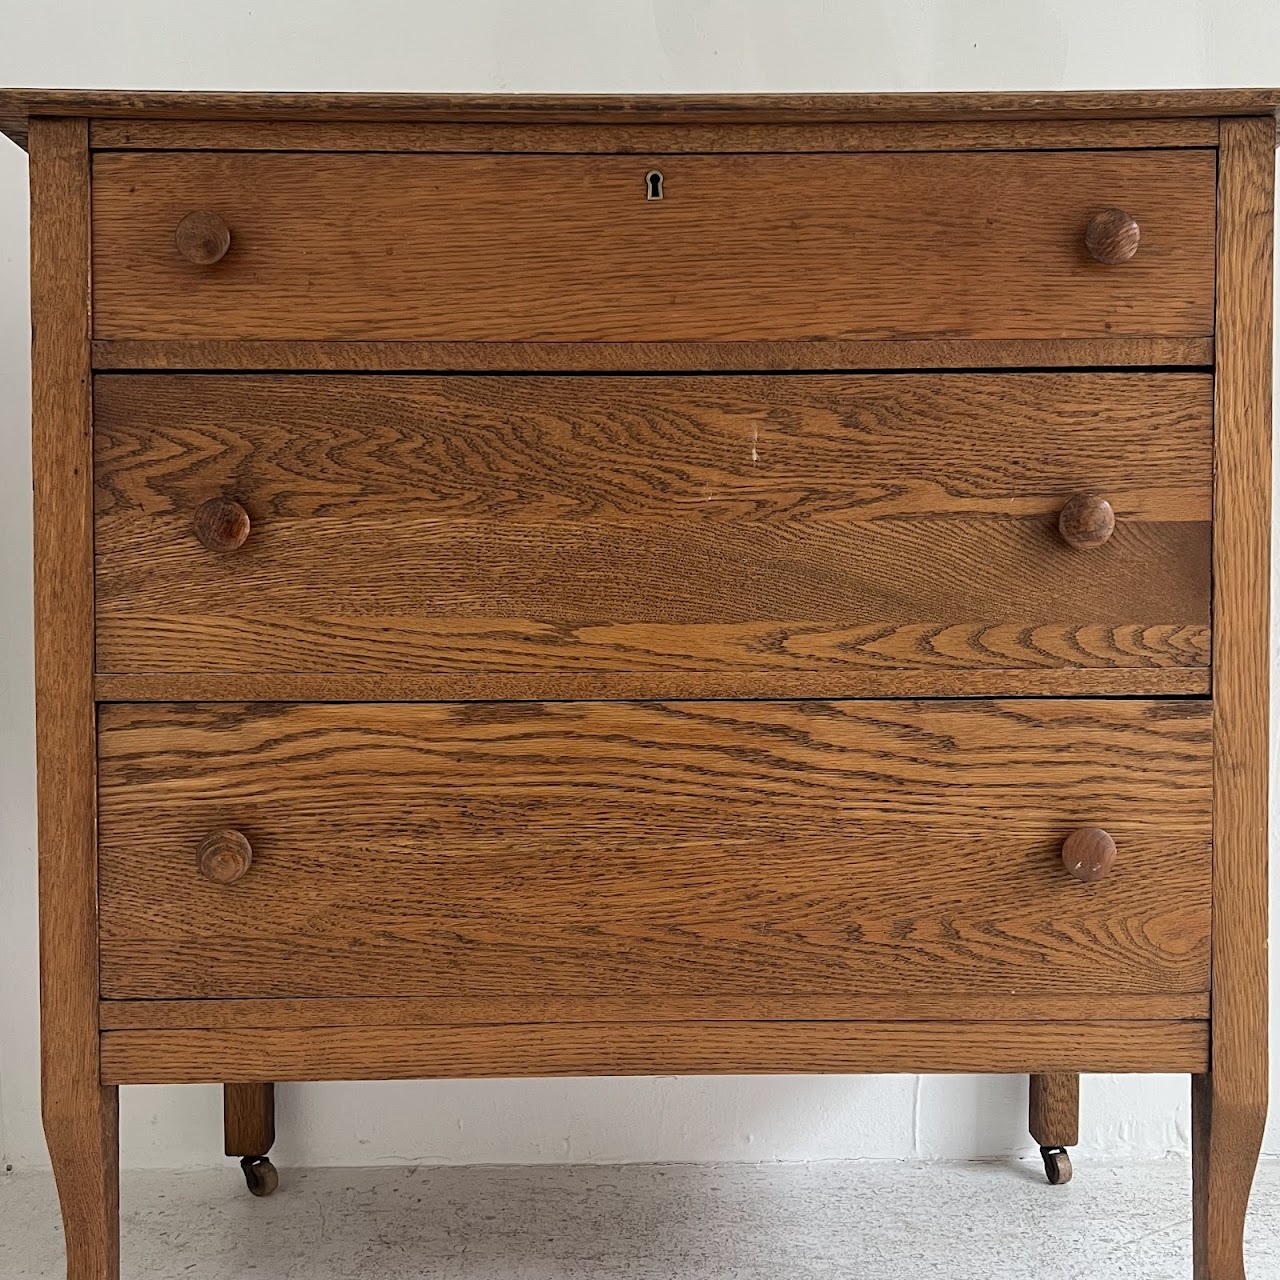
[90,118,1217,155]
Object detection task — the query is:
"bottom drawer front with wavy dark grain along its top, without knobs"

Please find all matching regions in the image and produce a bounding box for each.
[99,699,1211,1015]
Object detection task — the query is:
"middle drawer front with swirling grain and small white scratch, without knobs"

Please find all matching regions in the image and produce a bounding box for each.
[95,374,1212,696]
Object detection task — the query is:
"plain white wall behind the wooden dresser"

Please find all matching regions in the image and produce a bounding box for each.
[0,0,1280,1167]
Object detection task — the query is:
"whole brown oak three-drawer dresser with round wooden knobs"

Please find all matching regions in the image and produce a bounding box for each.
[0,90,1280,1280]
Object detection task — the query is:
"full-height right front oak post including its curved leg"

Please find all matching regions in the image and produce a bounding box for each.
[1192,119,1275,1280]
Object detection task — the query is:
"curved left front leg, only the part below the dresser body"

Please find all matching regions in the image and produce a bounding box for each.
[44,1082,120,1280]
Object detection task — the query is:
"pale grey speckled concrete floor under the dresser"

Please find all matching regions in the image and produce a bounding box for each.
[0,1161,1280,1280]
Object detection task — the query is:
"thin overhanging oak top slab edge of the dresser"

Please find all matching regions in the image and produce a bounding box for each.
[0,88,1280,145]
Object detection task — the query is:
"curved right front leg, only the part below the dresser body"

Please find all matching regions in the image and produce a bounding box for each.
[1192,1074,1267,1280]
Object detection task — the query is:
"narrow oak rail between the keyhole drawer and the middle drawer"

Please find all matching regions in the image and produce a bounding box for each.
[93,337,1213,372]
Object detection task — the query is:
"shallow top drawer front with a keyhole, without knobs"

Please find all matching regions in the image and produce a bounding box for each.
[93,148,1216,342]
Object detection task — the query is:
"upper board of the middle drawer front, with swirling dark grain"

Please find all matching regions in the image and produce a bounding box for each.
[95,374,1212,524]
